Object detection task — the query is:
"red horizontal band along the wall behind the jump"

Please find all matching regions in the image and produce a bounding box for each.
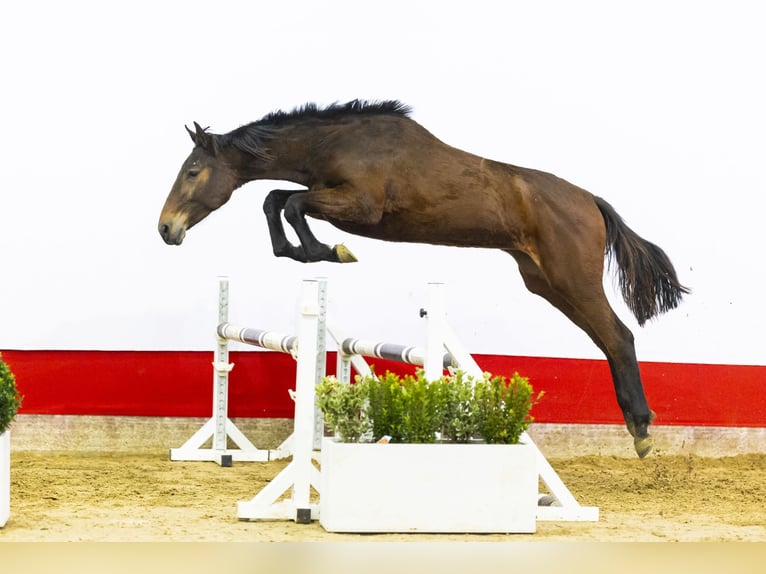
[2,350,766,427]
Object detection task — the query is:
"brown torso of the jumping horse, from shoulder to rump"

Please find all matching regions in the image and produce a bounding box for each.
[316,116,603,250]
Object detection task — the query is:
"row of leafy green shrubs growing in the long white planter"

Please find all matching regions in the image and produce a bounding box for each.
[317,371,542,444]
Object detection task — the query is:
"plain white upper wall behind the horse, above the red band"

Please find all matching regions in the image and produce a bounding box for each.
[0,0,766,364]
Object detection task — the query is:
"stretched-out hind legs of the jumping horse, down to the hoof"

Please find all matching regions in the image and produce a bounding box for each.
[508,251,653,458]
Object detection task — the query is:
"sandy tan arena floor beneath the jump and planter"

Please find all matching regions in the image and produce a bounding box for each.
[0,452,766,542]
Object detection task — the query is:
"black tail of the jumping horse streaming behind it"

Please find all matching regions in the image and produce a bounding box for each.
[595,197,690,325]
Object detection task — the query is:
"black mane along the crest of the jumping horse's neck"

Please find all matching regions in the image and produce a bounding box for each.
[218,100,412,159]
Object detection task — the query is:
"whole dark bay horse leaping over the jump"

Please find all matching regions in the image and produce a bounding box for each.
[158,100,689,458]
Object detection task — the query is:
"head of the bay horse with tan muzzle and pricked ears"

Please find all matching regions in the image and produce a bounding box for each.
[158,122,241,245]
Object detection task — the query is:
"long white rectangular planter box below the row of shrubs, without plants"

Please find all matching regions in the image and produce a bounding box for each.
[319,438,538,533]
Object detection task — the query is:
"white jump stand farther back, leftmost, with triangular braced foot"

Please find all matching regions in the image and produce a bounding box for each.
[170,277,282,466]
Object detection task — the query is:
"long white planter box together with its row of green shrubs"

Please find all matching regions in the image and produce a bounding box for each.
[317,372,540,533]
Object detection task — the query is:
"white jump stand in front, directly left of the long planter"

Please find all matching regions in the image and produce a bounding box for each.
[237,281,325,524]
